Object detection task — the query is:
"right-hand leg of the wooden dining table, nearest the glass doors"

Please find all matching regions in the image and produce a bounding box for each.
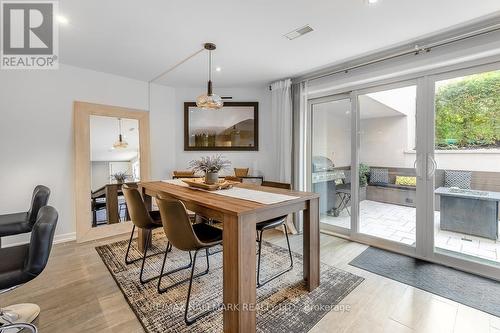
[303,198,320,291]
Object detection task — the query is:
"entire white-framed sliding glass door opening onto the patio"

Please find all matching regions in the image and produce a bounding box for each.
[307,63,500,279]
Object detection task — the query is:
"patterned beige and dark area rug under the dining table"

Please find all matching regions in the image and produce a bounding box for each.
[96,233,363,333]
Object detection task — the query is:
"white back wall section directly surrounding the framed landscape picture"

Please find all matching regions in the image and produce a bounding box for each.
[168,87,277,180]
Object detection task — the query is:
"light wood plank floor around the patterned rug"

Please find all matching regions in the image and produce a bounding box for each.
[0,231,500,333]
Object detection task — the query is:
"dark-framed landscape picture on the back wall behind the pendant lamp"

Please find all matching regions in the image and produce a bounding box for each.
[184,102,259,151]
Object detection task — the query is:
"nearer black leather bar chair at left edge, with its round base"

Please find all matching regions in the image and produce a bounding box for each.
[0,206,58,333]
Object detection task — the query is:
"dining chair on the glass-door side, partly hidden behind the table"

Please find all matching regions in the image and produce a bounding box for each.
[257,181,293,288]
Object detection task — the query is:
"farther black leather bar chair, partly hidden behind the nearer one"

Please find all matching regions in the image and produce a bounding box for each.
[0,185,50,245]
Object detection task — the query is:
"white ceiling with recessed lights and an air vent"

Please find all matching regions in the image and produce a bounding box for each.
[59,0,500,88]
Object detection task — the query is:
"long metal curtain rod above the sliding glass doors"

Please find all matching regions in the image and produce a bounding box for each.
[294,23,500,81]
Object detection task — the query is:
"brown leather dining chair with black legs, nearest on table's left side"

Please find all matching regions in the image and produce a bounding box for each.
[157,197,222,325]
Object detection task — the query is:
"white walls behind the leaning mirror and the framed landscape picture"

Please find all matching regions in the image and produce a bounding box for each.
[0,65,273,244]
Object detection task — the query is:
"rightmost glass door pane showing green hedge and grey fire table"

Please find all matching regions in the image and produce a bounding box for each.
[431,70,500,265]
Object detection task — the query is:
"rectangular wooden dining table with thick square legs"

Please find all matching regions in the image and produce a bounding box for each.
[138,181,320,333]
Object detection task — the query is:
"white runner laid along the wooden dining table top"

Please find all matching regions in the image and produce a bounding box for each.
[162,179,299,205]
